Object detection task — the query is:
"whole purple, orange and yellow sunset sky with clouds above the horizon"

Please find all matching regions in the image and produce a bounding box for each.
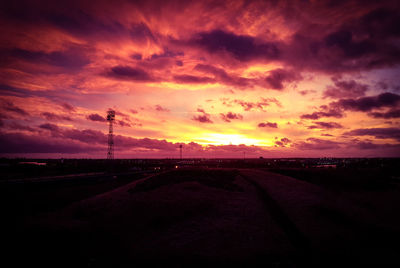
[0,0,400,158]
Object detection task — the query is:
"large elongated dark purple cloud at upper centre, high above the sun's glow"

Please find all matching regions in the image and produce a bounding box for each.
[190,30,280,61]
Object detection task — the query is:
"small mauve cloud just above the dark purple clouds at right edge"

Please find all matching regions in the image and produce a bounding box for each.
[323,77,368,99]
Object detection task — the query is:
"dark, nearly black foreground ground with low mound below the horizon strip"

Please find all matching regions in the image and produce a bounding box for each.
[0,168,400,267]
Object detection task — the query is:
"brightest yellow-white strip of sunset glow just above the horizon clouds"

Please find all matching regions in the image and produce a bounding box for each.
[193,133,272,146]
